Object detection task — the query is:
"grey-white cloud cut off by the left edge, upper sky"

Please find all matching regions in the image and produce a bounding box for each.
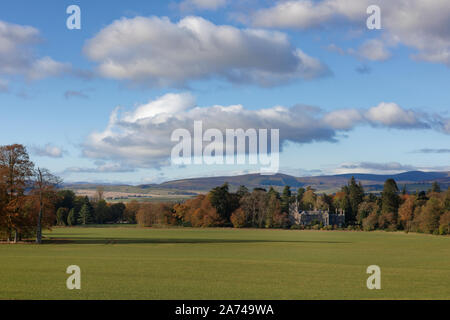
[0,21,71,80]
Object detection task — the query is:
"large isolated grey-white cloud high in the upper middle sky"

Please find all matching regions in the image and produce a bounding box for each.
[84,16,329,86]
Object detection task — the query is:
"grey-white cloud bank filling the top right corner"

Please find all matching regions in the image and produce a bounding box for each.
[250,0,450,66]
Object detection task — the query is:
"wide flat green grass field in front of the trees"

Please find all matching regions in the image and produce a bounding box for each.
[0,226,450,299]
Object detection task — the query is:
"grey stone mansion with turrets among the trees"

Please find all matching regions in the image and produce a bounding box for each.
[289,202,345,227]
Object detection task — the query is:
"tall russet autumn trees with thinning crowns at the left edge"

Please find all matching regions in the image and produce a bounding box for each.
[0,144,60,243]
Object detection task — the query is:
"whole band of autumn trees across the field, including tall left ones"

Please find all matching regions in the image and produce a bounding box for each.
[0,144,450,243]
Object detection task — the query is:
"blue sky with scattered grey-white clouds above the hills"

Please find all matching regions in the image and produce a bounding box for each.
[0,0,450,184]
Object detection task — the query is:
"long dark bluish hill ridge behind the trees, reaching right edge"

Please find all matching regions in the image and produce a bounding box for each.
[139,171,450,192]
